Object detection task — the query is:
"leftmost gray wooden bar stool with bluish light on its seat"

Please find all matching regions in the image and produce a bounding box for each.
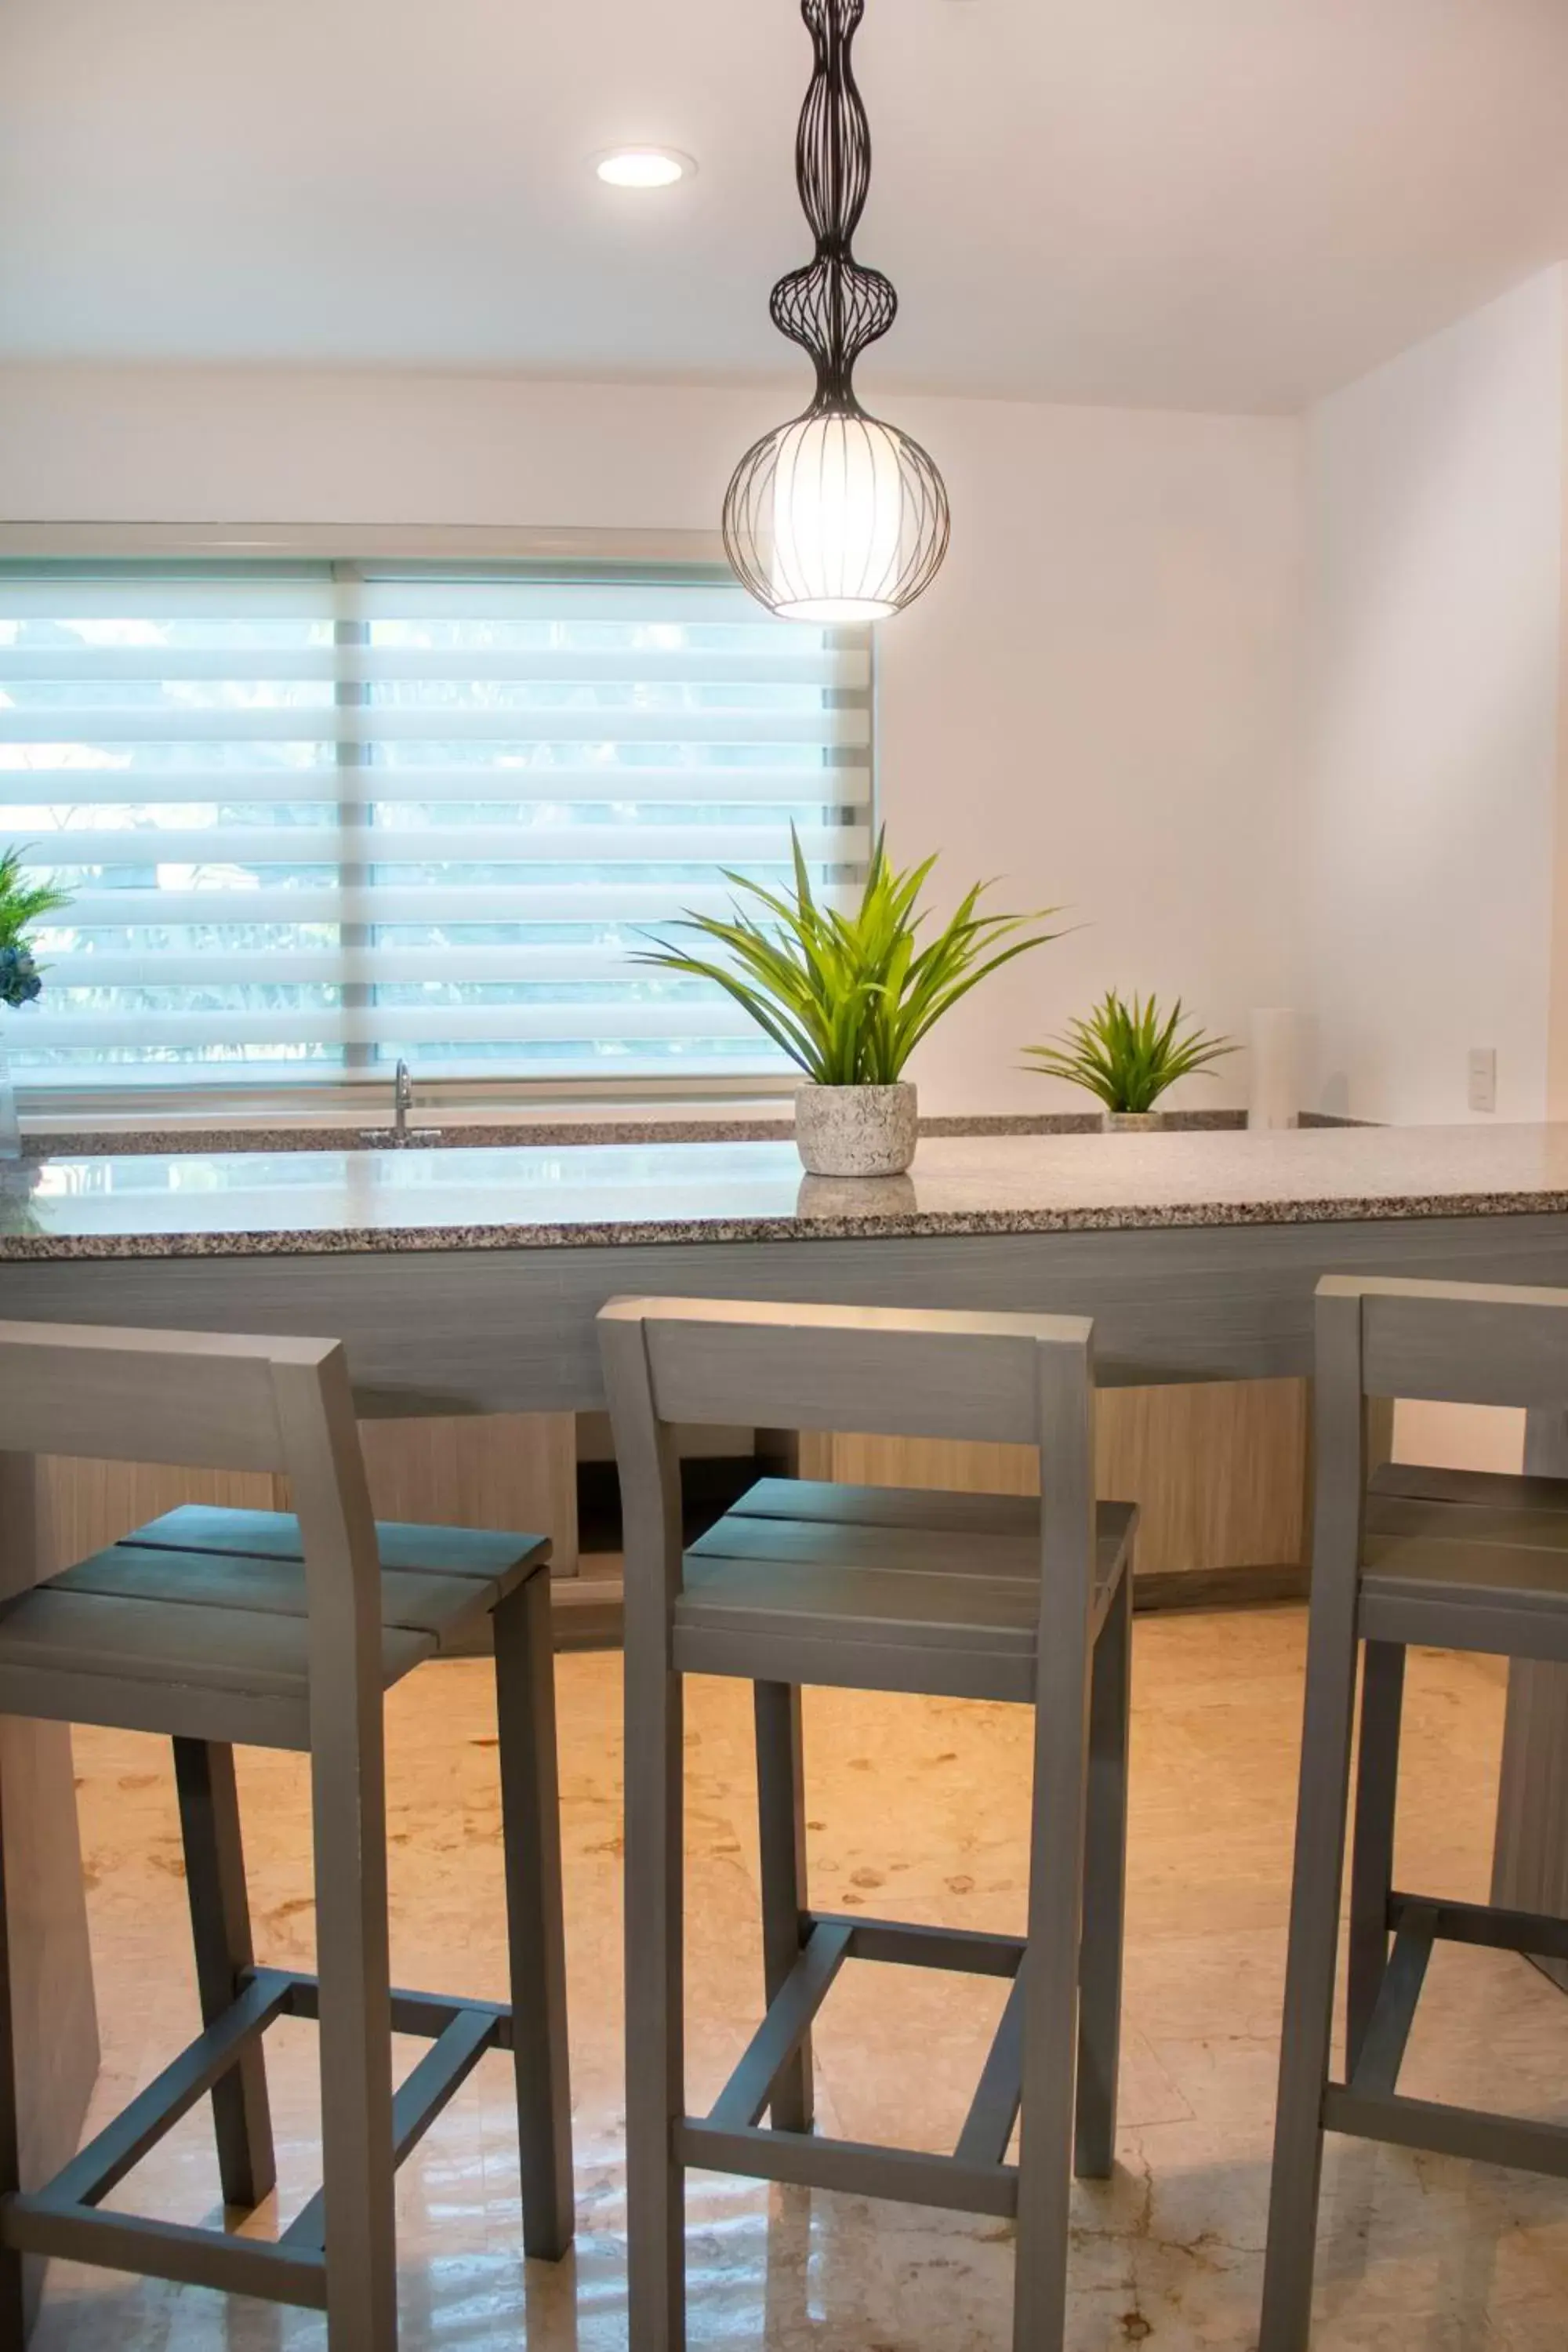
[0,1324,572,2352]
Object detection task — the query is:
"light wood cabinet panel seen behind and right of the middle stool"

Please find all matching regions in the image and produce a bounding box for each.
[799,1381,1307,1576]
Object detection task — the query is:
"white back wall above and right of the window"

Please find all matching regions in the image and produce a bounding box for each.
[0,369,1300,1112]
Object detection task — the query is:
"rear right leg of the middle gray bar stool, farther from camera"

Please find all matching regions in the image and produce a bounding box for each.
[1074,1562,1133,2180]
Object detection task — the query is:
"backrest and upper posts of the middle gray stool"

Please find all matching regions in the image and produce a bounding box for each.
[600,1298,1095,1646]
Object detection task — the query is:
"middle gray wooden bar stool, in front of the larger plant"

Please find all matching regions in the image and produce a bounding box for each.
[600,1298,1135,2352]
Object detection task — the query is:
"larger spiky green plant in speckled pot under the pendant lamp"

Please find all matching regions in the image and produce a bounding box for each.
[637,830,1055,1176]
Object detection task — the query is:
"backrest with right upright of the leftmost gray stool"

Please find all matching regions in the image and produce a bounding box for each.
[0,1322,381,1762]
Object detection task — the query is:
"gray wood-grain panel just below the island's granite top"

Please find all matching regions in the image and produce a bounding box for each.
[0,1211,1568,1416]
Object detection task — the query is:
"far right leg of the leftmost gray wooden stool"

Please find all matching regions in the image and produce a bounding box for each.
[492,1571,574,2263]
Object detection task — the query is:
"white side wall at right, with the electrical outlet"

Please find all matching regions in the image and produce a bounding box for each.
[1300,270,1563,1122]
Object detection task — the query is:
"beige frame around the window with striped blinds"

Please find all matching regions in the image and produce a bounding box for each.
[0,522,881,1129]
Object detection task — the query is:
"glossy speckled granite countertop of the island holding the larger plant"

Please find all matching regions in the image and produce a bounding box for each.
[0,1124,1568,1258]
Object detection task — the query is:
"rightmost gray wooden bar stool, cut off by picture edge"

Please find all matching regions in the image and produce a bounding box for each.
[1260,1277,1568,2352]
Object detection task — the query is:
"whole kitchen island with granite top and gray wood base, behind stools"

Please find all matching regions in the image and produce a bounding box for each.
[0,1127,1568,2249]
